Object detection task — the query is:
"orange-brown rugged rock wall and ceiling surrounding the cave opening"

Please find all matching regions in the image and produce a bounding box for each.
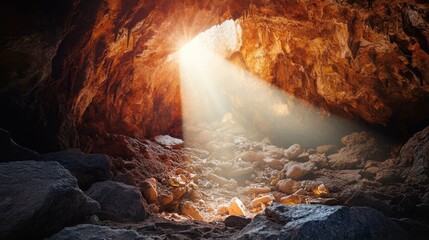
[0,0,429,151]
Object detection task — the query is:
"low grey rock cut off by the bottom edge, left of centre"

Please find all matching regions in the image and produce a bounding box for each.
[47,224,152,240]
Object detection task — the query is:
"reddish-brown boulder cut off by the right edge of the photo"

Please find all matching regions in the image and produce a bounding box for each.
[396,126,429,184]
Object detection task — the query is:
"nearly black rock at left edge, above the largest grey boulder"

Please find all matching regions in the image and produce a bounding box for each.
[0,128,39,162]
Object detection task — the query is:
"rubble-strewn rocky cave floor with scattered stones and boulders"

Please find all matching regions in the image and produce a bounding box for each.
[0,114,429,239]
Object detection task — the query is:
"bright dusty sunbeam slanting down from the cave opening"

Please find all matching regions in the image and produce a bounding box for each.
[179,20,358,148]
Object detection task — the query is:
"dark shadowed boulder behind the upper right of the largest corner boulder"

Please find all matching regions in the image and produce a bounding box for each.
[39,149,113,190]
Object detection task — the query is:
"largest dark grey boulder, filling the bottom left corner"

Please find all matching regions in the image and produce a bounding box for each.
[0,161,100,239]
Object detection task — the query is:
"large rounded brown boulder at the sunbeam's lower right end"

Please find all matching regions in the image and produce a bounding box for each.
[328,132,381,169]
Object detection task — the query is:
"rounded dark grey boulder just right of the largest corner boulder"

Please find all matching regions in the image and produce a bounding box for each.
[86,181,146,221]
